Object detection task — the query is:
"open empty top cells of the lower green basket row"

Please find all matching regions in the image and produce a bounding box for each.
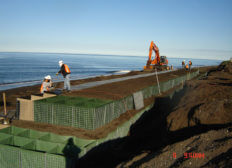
[0,126,95,156]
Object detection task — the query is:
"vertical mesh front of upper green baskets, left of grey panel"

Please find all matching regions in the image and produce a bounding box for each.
[34,96,134,130]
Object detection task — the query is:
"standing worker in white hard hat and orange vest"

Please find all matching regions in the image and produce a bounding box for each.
[56,60,71,92]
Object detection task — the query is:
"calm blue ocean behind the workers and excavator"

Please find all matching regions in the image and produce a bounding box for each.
[0,52,221,90]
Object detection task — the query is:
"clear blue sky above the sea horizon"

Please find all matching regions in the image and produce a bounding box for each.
[0,0,232,59]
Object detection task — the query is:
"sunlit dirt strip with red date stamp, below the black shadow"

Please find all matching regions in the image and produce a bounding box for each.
[117,128,232,168]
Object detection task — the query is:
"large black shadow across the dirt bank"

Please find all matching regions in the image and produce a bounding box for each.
[77,87,232,168]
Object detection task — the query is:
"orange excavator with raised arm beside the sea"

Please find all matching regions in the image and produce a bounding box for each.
[144,41,169,70]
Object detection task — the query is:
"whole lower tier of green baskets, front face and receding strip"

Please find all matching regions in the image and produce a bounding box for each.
[0,83,188,168]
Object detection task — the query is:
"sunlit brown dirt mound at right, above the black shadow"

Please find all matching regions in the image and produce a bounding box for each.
[167,62,232,131]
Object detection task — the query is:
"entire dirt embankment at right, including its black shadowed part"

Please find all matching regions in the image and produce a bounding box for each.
[79,63,232,168]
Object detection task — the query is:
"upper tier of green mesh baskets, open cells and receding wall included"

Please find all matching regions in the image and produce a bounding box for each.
[34,71,199,130]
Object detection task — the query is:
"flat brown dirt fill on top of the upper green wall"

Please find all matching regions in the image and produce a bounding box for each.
[63,69,192,100]
